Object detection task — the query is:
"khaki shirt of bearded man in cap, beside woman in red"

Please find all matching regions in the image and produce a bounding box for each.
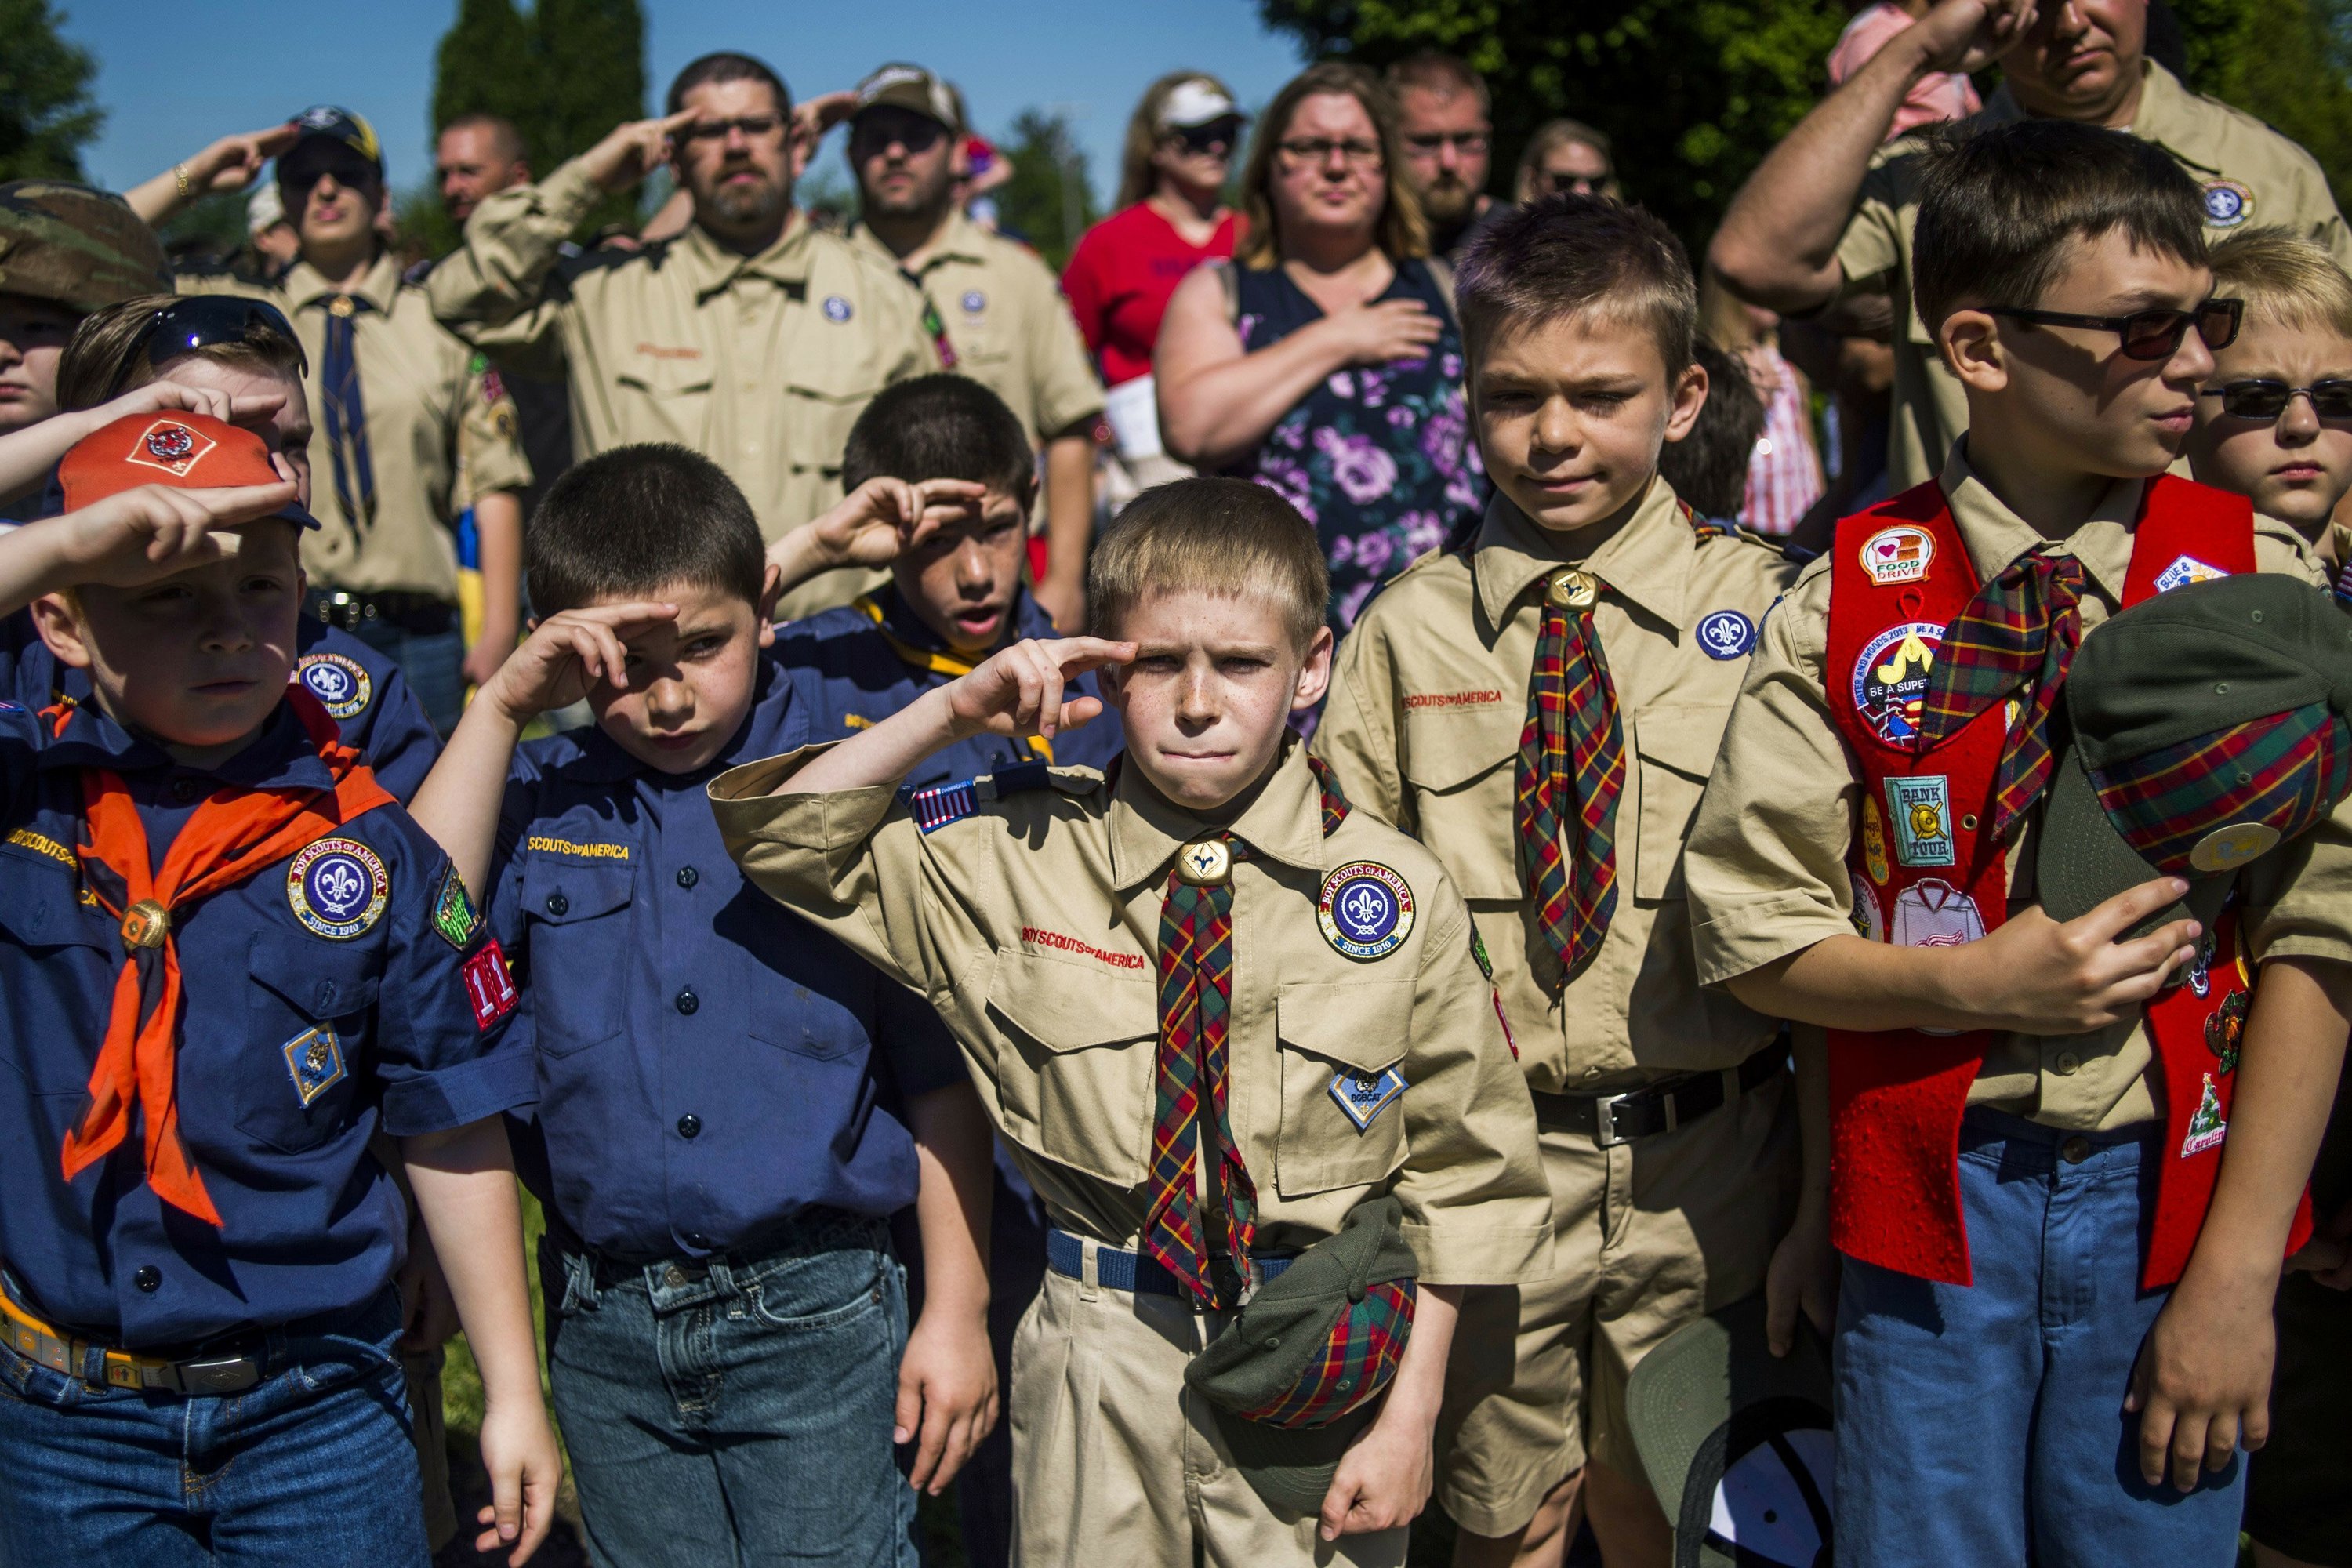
[849,212,1103,447]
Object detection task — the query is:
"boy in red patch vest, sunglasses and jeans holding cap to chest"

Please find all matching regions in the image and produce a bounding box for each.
[1684,120,2352,1566]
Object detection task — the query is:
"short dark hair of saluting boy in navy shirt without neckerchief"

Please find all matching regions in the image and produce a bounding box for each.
[522,445,767,616]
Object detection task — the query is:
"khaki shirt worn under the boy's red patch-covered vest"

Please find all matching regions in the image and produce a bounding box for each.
[1682,442,2352,1131]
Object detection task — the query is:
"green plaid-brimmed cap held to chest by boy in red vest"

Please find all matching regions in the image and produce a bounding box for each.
[2037,574,2352,928]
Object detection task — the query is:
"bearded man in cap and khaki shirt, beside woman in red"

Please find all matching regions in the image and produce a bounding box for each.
[849,66,1103,630]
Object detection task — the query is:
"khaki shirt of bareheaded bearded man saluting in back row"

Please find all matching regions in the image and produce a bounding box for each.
[426,160,938,616]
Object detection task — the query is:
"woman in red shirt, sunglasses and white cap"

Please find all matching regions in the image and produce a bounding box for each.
[1061,71,1247,489]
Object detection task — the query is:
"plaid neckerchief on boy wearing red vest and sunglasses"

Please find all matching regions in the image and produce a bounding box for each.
[1917,555,2084,839]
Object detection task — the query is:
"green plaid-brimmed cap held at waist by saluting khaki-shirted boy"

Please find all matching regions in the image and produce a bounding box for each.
[1183,1196,1416,1514]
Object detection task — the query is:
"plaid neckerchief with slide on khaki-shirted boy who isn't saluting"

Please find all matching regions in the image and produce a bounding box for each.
[1512,569,1625,987]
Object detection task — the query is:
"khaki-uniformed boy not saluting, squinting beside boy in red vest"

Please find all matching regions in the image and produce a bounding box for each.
[1315,198,1797,1563]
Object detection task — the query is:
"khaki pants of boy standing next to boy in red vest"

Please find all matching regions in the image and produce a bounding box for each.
[1437,1074,1802,1535]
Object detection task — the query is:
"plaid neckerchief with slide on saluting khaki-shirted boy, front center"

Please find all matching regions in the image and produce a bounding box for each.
[1143,760,1348,1307]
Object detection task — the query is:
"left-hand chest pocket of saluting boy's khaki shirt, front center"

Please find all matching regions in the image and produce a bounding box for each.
[988,952,1160,1187]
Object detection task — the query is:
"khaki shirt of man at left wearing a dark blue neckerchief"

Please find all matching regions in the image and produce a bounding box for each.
[179,254,532,604]
